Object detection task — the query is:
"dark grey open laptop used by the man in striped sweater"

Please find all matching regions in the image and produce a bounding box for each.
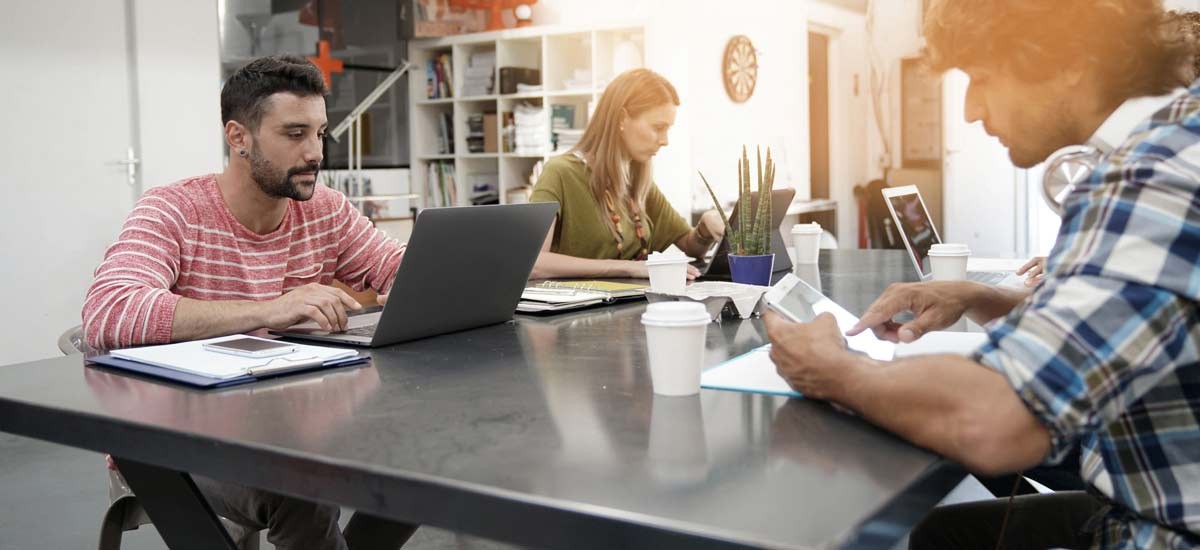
[271,203,558,347]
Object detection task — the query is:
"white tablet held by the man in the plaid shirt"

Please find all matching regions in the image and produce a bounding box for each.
[762,274,895,360]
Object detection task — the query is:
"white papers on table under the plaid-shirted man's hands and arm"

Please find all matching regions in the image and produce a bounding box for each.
[700,331,988,397]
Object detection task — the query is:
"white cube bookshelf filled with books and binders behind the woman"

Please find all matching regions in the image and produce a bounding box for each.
[408,24,646,208]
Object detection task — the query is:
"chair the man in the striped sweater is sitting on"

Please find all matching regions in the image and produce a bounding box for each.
[59,325,259,550]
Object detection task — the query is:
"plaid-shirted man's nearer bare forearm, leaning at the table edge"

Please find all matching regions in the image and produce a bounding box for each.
[833,355,1050,473]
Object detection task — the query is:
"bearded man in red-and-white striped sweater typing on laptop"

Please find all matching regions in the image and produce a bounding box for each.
[83,56,415,550]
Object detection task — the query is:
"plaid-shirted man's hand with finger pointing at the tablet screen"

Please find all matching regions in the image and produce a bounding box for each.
[846,281,974,343]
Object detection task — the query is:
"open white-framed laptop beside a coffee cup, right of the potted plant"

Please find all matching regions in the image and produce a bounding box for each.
[883,185,1024,286]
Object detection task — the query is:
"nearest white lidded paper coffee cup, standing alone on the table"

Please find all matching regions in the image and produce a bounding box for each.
[642,301,712,395]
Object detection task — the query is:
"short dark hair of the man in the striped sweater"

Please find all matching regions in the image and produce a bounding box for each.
[221,55,329,130]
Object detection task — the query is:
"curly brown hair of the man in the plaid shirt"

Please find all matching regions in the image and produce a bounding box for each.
[924,0,1194,100]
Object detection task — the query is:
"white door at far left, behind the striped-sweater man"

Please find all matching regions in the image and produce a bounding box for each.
[0,0,138,365]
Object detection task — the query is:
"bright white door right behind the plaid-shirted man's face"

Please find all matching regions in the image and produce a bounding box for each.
[942,71,1025,258]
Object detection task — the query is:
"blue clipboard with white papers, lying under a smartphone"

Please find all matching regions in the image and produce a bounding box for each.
[88,335,370,389]
